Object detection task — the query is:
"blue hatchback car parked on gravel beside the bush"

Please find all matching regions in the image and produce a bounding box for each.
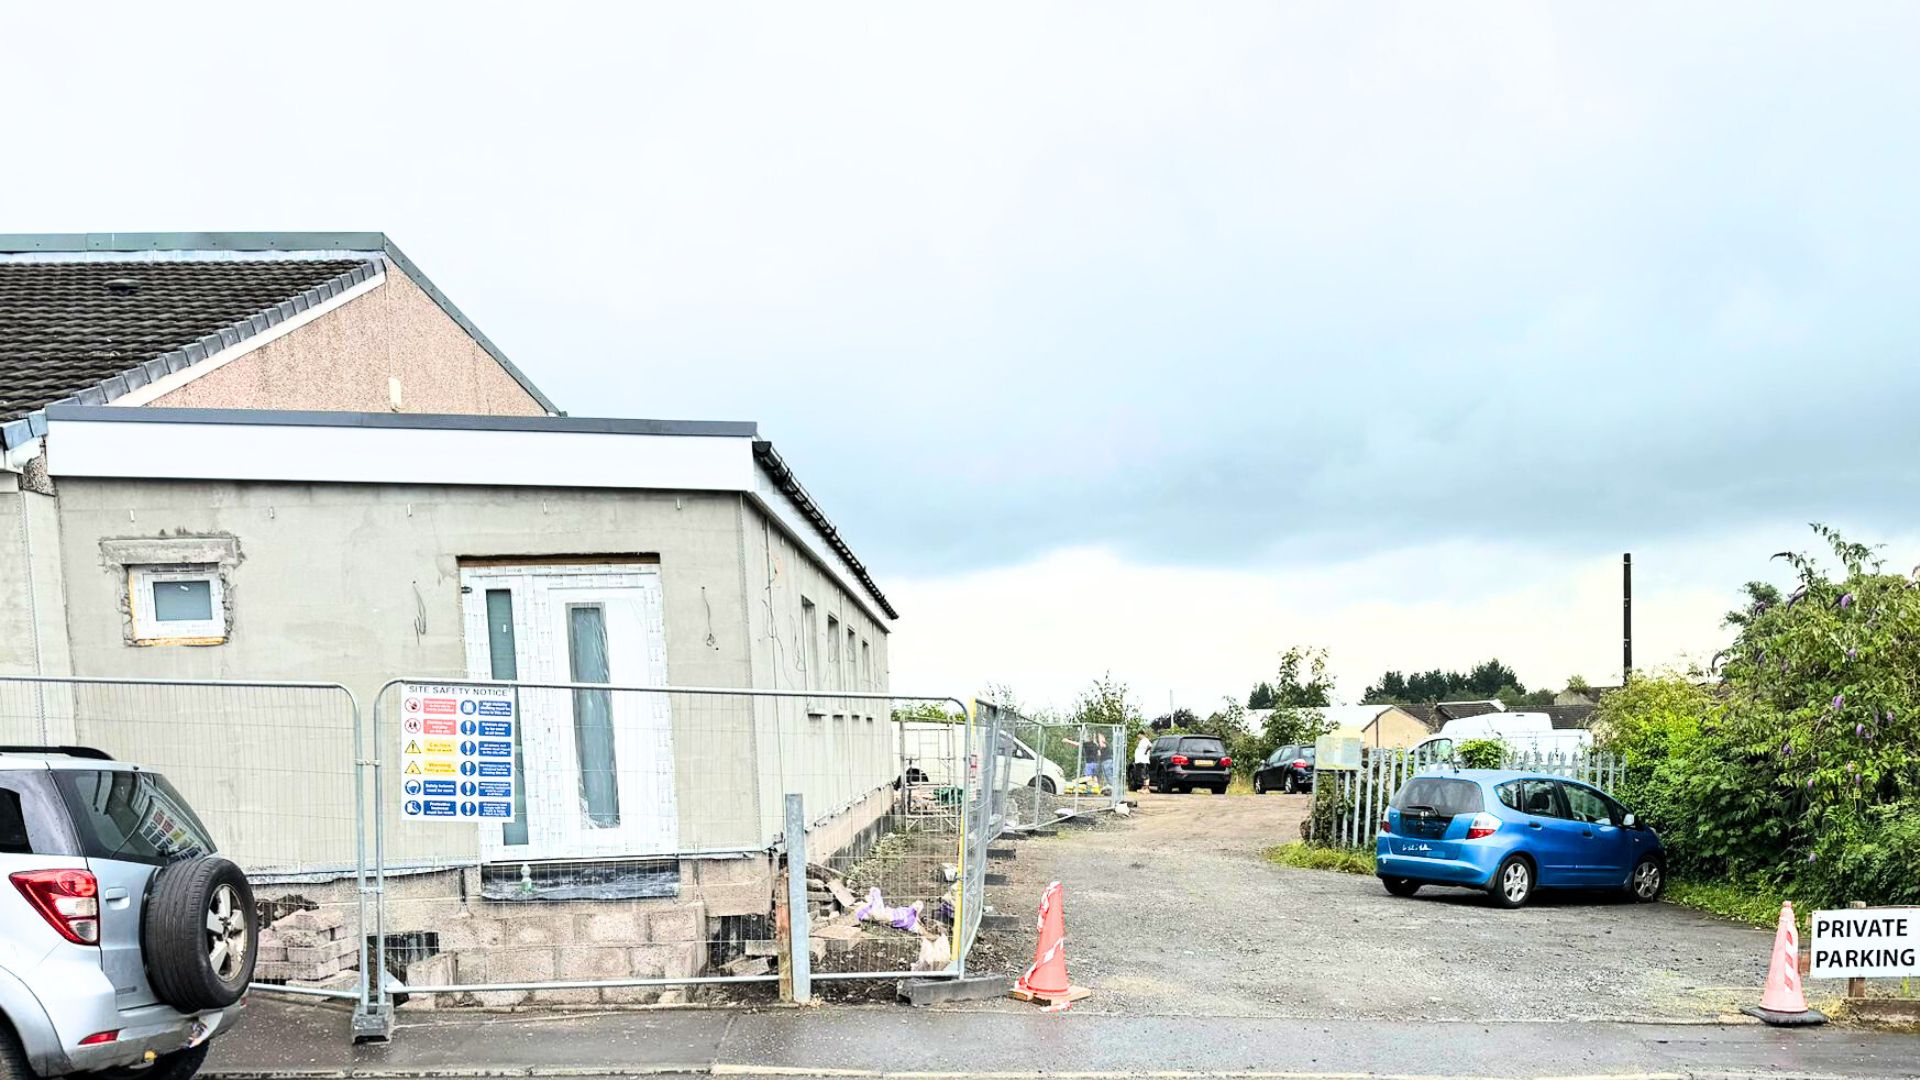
[1373,769,1667,907]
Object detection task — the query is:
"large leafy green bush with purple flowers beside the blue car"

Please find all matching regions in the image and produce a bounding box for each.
[1596,527,1920,905]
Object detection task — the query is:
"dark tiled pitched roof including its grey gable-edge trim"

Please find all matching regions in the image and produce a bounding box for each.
[0,233,559,448]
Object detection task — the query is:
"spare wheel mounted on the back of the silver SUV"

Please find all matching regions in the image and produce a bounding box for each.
[140,857,259,1013]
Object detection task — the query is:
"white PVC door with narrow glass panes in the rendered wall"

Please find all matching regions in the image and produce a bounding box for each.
[461,565,678,861]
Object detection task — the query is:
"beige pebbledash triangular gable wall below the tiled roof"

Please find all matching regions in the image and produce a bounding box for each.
[150,261,545,417]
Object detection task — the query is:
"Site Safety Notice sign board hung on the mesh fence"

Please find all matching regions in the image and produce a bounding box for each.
[399,682,520,824]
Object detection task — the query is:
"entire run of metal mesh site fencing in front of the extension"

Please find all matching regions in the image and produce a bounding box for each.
[0,676,1020,1038]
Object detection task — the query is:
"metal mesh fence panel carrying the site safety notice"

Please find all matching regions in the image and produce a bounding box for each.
[371,678,995,1005]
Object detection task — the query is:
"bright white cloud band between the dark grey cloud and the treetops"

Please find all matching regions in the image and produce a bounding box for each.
[889,527,1920,715]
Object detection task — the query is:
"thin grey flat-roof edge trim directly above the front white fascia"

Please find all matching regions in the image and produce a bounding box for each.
[46,404,760,438]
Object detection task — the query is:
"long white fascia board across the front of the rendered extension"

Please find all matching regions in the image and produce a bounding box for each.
[46,419,758,492]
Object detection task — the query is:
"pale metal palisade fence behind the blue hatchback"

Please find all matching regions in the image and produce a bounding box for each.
[1309,748,1620,847]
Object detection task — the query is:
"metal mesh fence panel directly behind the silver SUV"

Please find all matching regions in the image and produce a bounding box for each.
[0,676,369,999]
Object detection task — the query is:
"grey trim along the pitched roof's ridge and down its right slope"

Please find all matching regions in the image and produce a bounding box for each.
[0,233,561,413]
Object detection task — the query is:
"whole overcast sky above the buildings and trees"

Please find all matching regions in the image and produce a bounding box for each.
[0,0,1920,709]
